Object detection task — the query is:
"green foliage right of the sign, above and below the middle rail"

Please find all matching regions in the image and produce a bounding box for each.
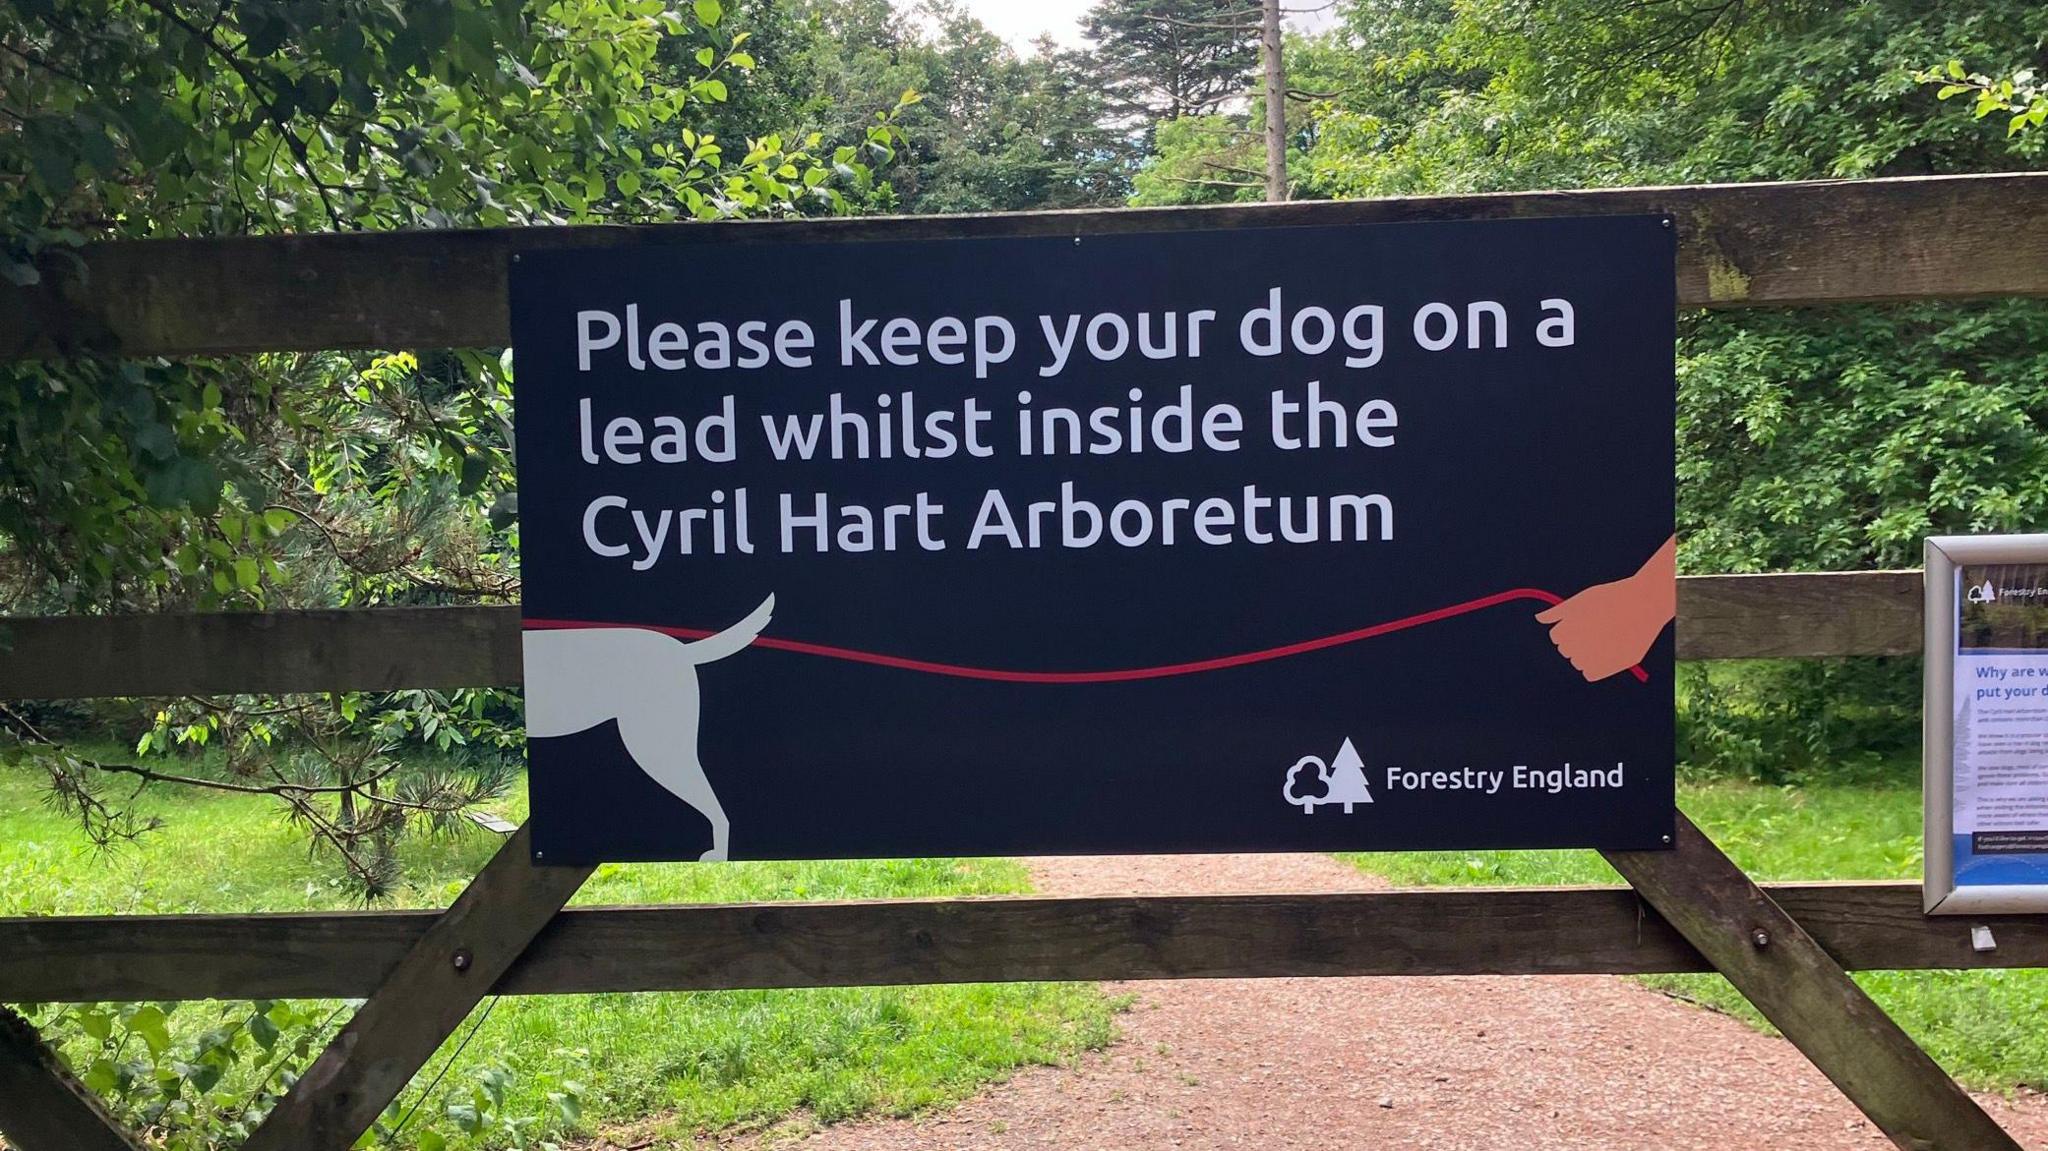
[1677,301,2048,782]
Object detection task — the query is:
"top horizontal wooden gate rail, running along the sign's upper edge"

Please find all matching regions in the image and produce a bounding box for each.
[0,174,2048,360]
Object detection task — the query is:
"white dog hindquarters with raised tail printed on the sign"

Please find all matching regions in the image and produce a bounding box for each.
[524,596,774,860]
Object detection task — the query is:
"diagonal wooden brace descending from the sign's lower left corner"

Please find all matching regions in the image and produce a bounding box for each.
[244,825,594,1151]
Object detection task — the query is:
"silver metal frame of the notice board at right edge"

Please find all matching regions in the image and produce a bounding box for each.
[1921,535,2048,915]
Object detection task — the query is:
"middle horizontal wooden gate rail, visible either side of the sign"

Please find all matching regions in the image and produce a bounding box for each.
[0,571,1921,698]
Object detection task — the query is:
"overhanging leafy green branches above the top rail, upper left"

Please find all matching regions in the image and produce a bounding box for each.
[0,0,897,236]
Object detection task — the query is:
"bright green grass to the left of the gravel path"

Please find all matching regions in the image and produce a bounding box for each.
[0,753,1114,1137]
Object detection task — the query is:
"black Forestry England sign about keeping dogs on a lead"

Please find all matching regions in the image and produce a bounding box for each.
[512,217,1675,862]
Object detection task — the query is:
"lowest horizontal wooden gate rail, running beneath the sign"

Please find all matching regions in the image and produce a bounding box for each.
[0,883,2048,1004]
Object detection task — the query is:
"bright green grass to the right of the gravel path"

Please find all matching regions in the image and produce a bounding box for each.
[1343,780,2048,1090]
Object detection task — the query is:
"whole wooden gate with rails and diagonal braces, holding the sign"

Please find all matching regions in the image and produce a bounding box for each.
[0,174,2048,1151]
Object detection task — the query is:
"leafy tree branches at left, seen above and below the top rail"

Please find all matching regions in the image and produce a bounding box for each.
[0,0,899,610]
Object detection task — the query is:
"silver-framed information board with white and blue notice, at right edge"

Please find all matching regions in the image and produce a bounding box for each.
[1923,535,2048,913]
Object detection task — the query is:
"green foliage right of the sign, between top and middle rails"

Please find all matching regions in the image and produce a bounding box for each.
[1677,301,2048,571]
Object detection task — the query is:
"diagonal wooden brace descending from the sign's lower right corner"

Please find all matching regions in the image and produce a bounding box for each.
[1602,815,2019,1151]
